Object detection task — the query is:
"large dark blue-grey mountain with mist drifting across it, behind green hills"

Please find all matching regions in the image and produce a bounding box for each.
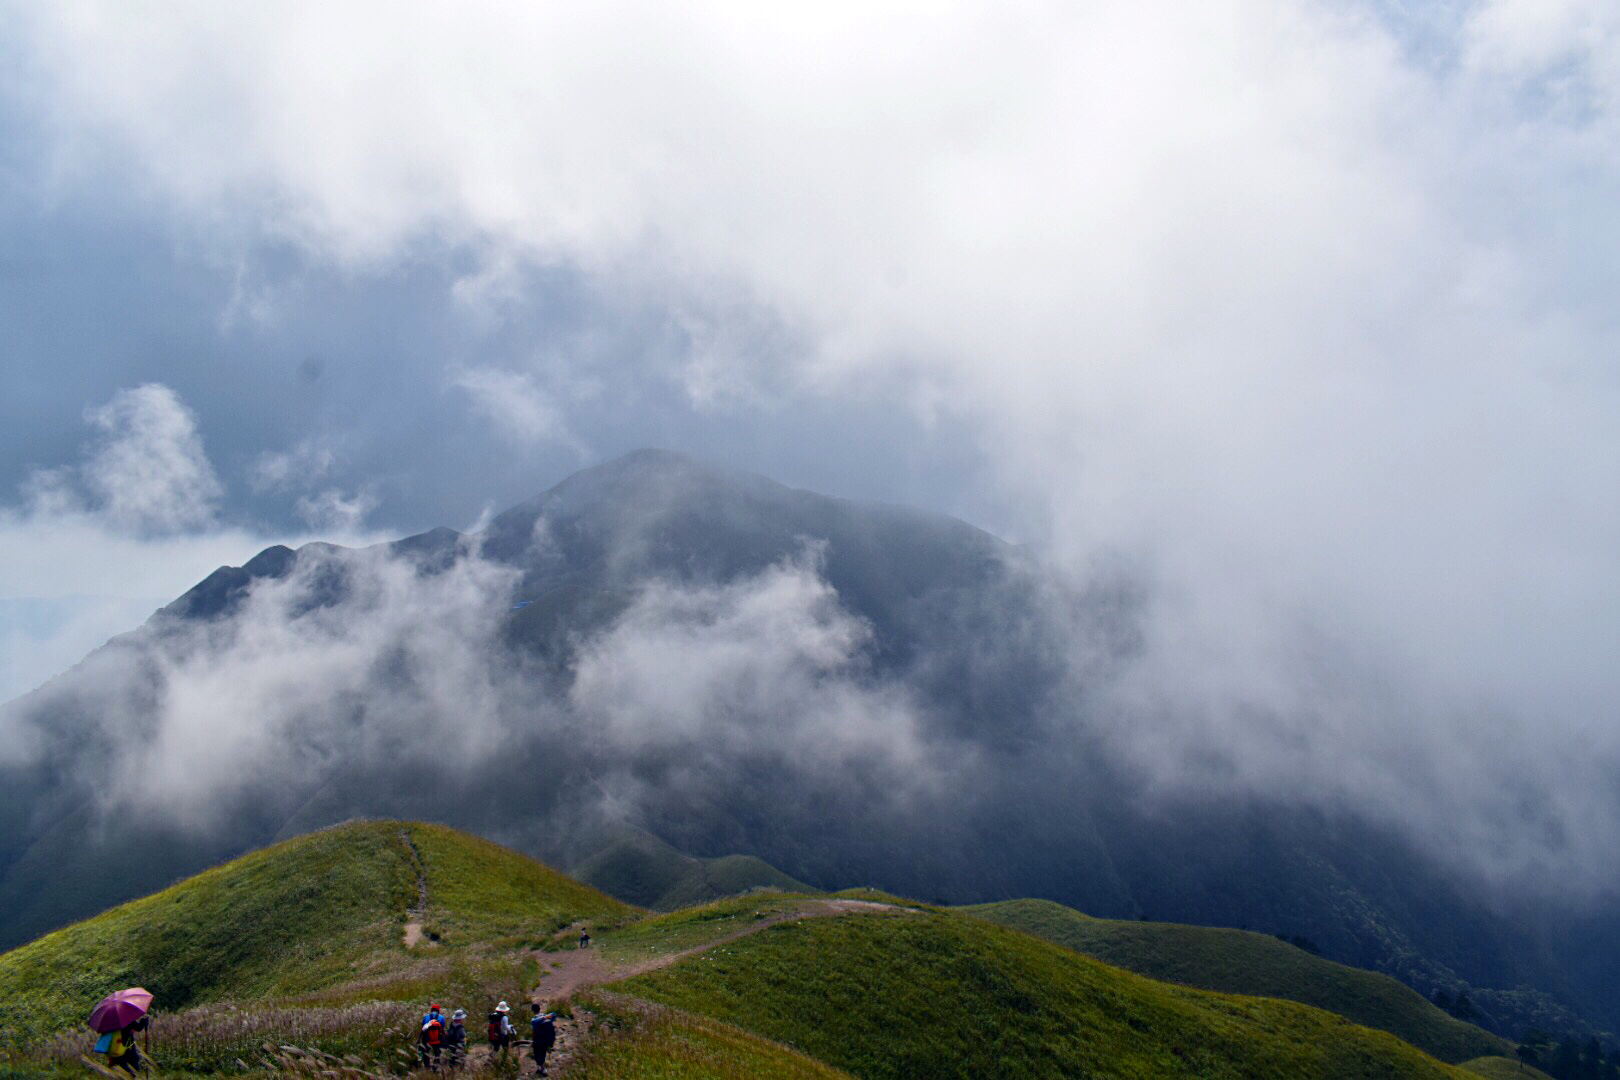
[0,450,1620,1033]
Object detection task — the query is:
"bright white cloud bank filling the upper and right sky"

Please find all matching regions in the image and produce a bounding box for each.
[13,0,1620,887]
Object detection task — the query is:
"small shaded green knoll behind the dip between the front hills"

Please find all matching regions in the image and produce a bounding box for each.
[573,832,813,912]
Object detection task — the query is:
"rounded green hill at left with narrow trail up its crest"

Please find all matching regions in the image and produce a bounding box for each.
[0,821,629,1043]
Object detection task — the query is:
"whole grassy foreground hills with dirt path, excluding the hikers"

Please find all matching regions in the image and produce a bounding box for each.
[0,821,1494,1080]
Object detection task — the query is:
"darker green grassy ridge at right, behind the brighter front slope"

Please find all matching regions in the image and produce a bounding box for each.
[959,900,1516,1064]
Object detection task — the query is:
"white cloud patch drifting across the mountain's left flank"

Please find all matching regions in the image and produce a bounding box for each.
[97,546,517,829]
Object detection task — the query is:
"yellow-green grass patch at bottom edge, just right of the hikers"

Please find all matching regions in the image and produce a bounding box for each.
[569,999,849,1080]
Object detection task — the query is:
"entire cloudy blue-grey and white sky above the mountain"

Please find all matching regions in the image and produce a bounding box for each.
[0,0,1620,813]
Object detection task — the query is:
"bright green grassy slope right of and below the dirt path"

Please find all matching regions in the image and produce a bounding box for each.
[616,913,1466,1080]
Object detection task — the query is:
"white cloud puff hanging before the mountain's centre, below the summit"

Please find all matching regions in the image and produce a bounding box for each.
[569,551,935,780]
